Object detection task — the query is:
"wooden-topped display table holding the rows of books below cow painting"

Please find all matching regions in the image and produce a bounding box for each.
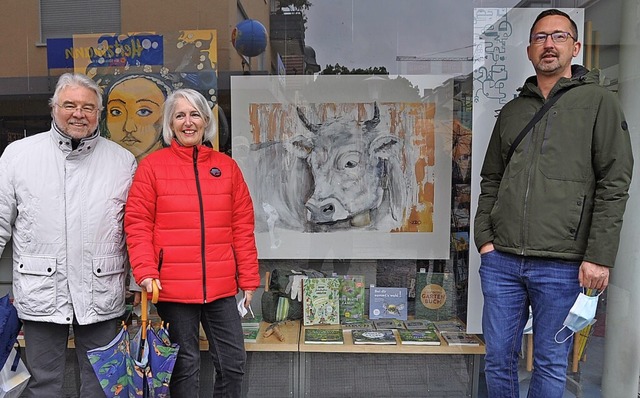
[299,326,485,397]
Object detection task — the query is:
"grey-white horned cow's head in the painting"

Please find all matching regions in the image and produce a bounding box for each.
[286,104,402,226]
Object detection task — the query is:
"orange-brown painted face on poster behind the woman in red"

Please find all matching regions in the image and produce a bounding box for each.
[106,76,165,160]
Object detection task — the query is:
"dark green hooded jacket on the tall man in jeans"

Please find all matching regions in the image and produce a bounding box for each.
[474,65,633,267]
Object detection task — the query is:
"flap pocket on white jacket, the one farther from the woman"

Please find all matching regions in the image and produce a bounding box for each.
[14,255,57,315]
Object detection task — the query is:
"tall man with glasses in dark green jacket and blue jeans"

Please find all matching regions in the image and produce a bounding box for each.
[474,10,633,398]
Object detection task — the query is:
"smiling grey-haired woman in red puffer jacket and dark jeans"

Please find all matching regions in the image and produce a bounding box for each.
[125,89,260,398]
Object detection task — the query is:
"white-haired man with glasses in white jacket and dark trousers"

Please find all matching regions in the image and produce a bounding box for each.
[0,74,136,398]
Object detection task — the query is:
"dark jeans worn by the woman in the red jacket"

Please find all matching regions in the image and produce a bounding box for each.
[156,296,247,398]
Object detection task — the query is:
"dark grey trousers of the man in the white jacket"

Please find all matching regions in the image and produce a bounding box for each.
[22,319,118,398]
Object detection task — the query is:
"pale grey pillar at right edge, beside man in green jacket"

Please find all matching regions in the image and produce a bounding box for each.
[602,0,640,397]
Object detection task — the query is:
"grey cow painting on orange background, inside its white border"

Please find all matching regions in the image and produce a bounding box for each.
[247,102,433,232]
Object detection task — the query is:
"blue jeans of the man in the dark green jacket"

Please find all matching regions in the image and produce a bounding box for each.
[480,250,580,398]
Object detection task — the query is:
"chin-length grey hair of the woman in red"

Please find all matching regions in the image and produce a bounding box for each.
[162,88,217,145]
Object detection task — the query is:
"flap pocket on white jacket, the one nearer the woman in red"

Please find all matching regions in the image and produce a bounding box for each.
[91,255,125,315]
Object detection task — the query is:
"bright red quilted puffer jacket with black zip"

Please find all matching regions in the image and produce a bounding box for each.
[124,140,260,304]
